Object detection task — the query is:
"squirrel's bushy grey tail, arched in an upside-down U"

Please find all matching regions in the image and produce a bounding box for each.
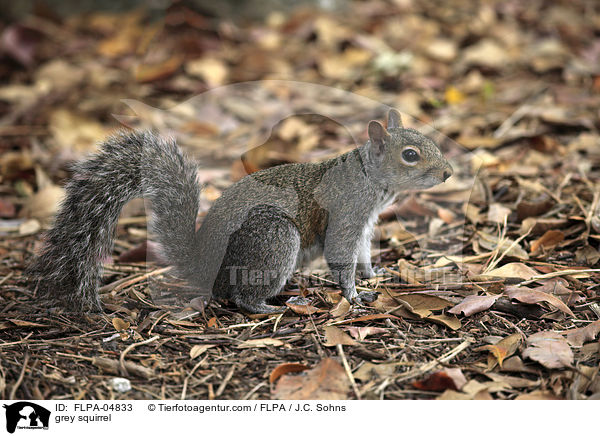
[28,132,200,311]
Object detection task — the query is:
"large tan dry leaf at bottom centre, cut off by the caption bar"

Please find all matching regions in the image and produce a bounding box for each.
[273,358,350,400]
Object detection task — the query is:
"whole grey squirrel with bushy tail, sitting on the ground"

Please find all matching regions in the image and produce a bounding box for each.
[29,109,452,313]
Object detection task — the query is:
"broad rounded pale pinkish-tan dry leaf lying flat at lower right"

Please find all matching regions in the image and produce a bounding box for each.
[523,331,573,369]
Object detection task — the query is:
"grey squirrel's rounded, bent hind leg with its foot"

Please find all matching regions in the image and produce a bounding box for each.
[215,206,300,313]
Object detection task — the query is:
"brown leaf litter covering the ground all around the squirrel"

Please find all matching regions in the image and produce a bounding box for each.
[0,0,600,399]
